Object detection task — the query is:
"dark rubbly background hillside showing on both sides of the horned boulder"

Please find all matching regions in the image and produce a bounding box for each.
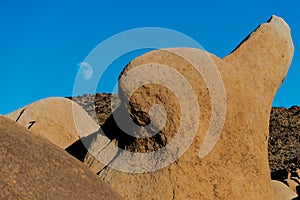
[72,93,300,176]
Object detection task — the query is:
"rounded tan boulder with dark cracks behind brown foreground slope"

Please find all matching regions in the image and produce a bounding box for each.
[6,97,99,149]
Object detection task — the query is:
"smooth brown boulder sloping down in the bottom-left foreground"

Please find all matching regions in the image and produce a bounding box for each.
[0,117,121,200]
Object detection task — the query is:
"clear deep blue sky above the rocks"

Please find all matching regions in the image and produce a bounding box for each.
[0,0,300,114]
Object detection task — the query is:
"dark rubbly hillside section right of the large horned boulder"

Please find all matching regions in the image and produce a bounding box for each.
[269,106,300,172]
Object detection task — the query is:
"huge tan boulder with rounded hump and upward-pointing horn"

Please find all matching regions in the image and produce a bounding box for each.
[84,16,294,199]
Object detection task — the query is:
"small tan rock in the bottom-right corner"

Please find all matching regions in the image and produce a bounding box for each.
[272,180,298,200]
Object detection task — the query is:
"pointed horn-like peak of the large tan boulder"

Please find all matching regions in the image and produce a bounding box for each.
[223,15,294,86]
